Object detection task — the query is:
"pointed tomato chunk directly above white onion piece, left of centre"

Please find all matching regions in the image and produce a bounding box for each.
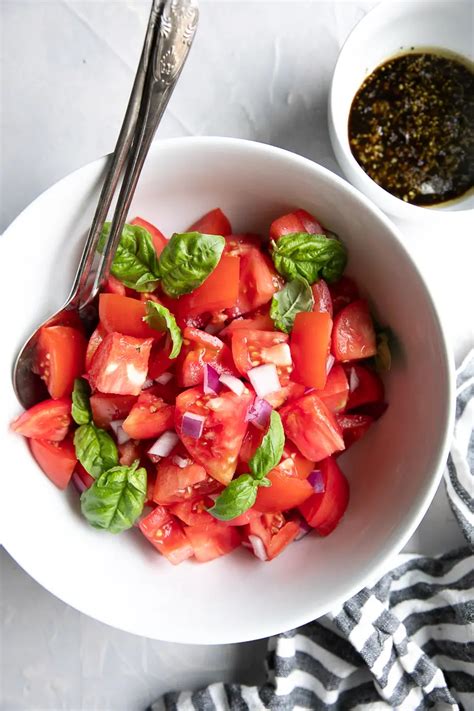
[122,388,174,439]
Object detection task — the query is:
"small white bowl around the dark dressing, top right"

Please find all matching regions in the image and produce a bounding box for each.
[328,0,474,224]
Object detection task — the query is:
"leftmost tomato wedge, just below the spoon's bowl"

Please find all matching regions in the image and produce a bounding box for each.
[10,397,71,442]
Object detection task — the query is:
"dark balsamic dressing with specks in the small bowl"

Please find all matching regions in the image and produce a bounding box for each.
[349,51,474,206]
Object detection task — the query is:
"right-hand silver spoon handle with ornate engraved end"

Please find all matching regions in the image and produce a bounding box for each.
[80,0,199,308]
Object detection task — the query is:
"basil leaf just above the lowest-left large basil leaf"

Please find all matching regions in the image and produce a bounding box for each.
[74,422,118,479]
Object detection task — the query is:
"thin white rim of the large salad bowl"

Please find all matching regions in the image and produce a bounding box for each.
[0,136,455,645]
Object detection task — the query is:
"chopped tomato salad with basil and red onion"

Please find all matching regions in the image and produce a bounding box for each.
[12,209,390,564]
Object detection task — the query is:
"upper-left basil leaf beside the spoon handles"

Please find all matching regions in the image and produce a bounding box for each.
[97,222,160,292]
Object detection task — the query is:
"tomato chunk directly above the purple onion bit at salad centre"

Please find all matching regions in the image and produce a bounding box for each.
[176,326,237,388]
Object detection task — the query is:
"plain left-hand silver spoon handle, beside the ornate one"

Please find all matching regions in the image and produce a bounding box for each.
[67,0,163,308]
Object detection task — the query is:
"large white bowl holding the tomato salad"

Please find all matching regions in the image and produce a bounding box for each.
[0,138,453,644]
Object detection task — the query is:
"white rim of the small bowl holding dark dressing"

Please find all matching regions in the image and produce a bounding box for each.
[328,0,474,220]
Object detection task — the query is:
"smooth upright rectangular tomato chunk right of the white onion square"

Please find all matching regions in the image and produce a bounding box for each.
[291,311,332,388]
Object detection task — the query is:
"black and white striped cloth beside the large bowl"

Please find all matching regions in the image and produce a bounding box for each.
[151,351,474,711]
